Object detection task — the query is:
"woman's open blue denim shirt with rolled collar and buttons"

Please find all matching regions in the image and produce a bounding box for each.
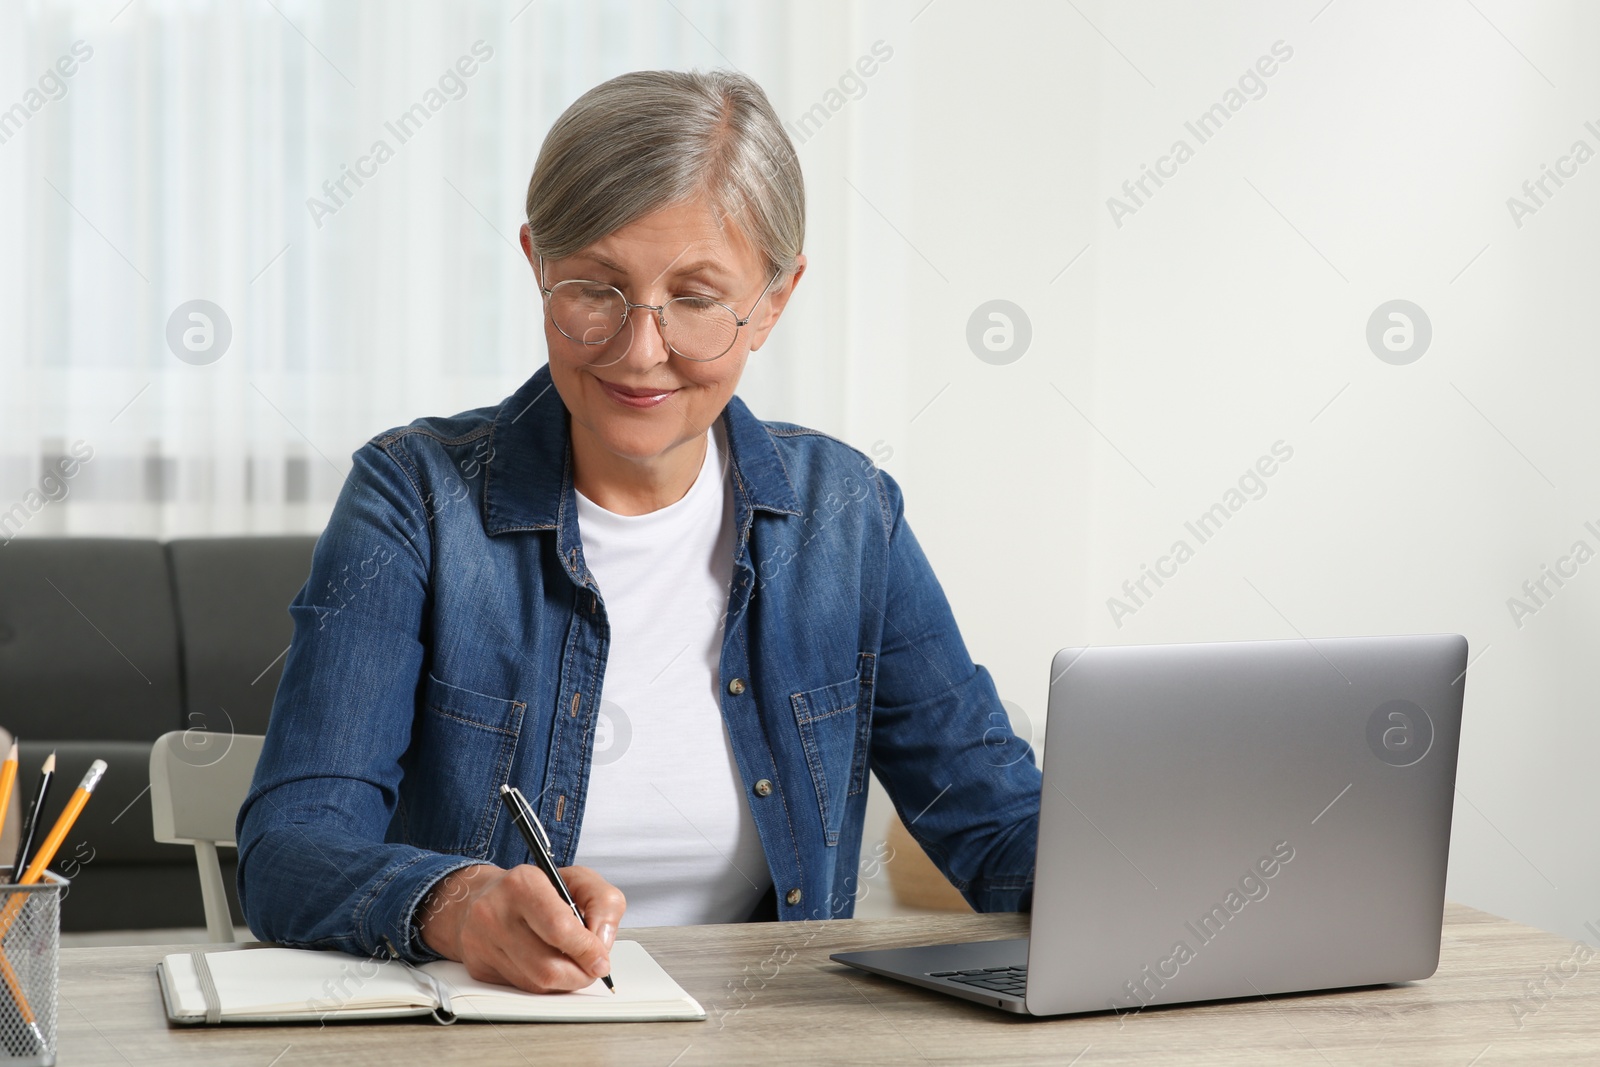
[237,366,1040,963]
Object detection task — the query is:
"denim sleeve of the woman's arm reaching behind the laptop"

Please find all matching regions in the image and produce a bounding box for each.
[872,472,1040,912]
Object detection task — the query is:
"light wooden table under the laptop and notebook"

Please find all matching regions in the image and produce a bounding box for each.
[59,904,1600,1067]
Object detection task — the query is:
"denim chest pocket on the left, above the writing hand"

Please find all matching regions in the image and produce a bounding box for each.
[400,673,526,859]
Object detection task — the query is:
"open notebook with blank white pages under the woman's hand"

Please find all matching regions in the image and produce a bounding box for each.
[155,941,706,1024]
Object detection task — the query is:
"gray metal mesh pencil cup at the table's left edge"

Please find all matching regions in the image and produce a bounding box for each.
[0,865,67,1067]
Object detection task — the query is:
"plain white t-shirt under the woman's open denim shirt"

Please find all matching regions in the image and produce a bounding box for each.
[576,421,773,926]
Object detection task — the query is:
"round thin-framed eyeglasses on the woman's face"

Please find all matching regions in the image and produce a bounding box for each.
[539,256,782,366]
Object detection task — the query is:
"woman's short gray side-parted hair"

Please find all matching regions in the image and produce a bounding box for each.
[528,70,805,274]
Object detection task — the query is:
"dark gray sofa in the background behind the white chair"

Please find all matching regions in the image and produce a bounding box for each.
[0,536,317,931]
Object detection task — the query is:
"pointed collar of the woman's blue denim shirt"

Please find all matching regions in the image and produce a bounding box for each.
[483,365,800,536]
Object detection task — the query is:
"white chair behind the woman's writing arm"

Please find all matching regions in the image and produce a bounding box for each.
[150,729,266,942]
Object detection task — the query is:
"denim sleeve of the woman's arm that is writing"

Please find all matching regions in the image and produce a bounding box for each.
[237,443,475,963]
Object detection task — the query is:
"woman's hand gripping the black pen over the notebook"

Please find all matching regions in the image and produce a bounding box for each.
[418,864,627,993]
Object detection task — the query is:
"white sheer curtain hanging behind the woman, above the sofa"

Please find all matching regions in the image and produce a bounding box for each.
[0,0,904,539]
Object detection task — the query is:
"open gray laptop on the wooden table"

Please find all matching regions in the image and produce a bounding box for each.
[832,633,1467,1016]
